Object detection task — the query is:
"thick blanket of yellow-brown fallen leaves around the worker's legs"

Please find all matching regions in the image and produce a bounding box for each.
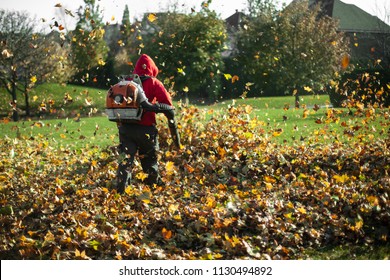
[0,106,390,259]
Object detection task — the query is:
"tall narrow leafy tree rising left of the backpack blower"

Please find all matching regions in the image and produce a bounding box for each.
[72,0,108,86]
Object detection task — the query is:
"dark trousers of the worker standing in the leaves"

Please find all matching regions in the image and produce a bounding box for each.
[117,124,159,193]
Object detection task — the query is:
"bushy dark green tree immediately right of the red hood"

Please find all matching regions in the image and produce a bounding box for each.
[138,5,226,99]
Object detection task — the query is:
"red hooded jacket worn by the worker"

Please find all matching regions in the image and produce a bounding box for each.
[133,54,172,126]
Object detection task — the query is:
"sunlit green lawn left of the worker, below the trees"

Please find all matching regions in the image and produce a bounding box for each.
[0,84,117,147]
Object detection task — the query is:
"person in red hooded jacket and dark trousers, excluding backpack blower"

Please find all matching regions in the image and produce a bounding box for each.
[116,54,174,193]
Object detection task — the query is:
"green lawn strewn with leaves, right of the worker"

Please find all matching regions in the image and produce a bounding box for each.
[201,95,389,144]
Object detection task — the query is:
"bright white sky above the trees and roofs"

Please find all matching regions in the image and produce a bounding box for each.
[0,0,390,29]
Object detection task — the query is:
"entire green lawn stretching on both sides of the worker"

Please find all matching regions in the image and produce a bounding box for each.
[0,84,388,146]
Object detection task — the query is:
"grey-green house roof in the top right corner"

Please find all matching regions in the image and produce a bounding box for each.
[332,0,390,33]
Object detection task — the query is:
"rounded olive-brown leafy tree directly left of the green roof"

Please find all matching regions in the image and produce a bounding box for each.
[273,0,349,102]
